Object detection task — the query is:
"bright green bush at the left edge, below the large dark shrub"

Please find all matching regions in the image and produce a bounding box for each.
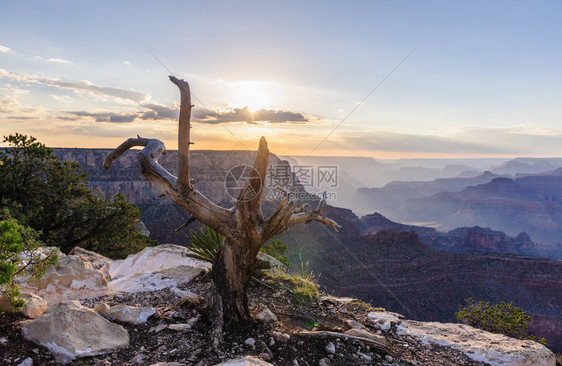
[0,210,59,311]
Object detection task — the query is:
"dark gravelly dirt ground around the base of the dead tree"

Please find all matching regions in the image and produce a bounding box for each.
[0,278,484,366]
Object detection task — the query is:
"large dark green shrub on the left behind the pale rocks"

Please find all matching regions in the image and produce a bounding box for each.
[0,133,154,258]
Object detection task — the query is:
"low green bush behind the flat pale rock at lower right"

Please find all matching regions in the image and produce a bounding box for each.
[455,298,546,345]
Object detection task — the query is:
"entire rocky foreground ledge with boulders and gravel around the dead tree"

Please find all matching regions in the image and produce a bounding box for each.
[0,245,556,366]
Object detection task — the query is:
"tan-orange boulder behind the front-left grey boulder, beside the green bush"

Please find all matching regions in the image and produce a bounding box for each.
[18,255,109,304]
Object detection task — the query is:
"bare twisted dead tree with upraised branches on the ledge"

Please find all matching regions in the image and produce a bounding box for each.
[104,76,338,347]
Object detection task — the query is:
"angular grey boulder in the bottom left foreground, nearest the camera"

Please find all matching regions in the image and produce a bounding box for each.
[22,301,129,363]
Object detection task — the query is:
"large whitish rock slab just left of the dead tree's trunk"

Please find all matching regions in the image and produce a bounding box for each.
[109,244,211,279]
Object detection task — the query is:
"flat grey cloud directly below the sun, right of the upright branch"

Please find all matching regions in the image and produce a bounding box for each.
[193,107,313,124]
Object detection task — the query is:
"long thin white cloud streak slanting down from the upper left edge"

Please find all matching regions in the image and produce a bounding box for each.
[0,69,147,103]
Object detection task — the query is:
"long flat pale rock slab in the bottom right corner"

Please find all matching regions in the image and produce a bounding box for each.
[396,320,556,366]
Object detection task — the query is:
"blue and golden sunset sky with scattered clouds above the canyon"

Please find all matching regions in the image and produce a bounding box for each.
[0,0,562,159]
